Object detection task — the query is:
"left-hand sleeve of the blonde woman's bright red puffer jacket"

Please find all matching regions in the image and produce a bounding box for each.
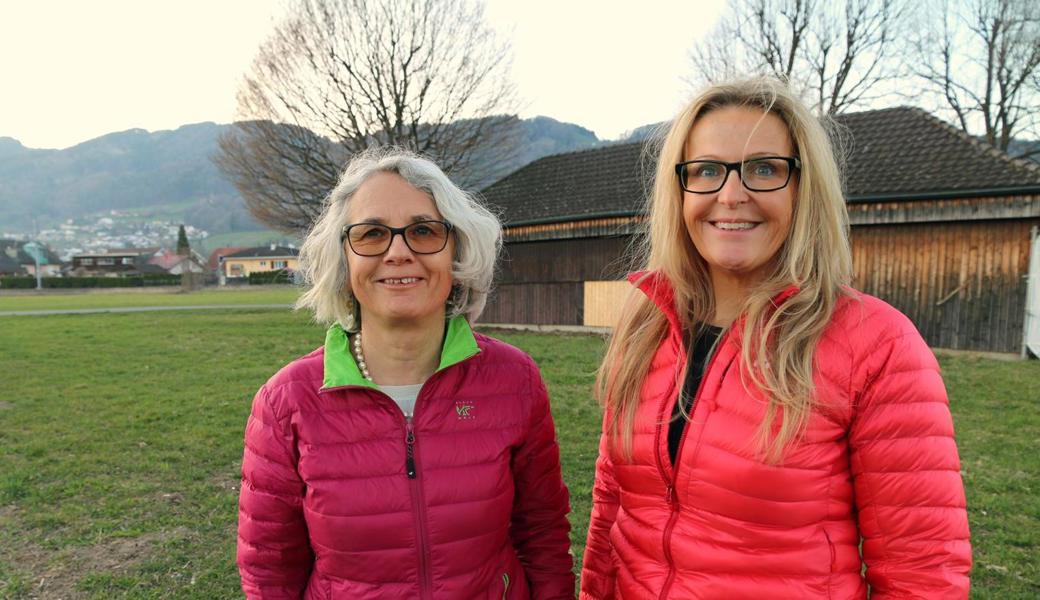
[579,415,618,600]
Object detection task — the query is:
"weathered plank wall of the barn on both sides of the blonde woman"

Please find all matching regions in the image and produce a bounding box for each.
[480,218,1040,353]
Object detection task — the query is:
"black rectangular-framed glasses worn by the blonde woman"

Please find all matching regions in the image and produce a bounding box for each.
[675,156,802,193]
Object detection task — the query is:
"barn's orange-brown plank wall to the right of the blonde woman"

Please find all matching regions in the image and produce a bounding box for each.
[852,219,1040,353]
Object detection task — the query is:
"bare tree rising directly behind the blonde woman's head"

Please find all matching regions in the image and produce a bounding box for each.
[690,0,906,113]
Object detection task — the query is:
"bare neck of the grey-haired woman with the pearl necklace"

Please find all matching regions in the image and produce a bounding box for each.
[361,312,444,386]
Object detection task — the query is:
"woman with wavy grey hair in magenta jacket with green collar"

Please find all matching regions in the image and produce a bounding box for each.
[238,150,574,599]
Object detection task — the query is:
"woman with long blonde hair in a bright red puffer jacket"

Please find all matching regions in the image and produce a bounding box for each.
[580,79,971,600]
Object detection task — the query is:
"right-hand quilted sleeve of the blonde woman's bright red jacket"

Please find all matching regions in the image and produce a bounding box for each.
[850,311,971,600]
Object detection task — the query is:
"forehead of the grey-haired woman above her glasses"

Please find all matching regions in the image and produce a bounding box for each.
[347,173,441,223]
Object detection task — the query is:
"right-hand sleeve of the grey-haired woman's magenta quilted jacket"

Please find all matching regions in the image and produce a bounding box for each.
[510,363,574,600]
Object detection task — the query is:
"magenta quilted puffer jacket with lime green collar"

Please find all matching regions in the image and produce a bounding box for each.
[238,317,574,600]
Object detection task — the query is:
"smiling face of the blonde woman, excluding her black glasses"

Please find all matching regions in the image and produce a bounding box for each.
[682,106,798,285]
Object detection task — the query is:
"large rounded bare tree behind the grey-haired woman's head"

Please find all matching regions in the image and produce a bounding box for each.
[214,0,518,232]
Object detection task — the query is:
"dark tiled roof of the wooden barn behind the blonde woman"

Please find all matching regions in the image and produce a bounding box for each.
[483,106,1040,226]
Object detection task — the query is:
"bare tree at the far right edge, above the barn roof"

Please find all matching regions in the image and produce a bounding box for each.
[913,0,1040,155]
